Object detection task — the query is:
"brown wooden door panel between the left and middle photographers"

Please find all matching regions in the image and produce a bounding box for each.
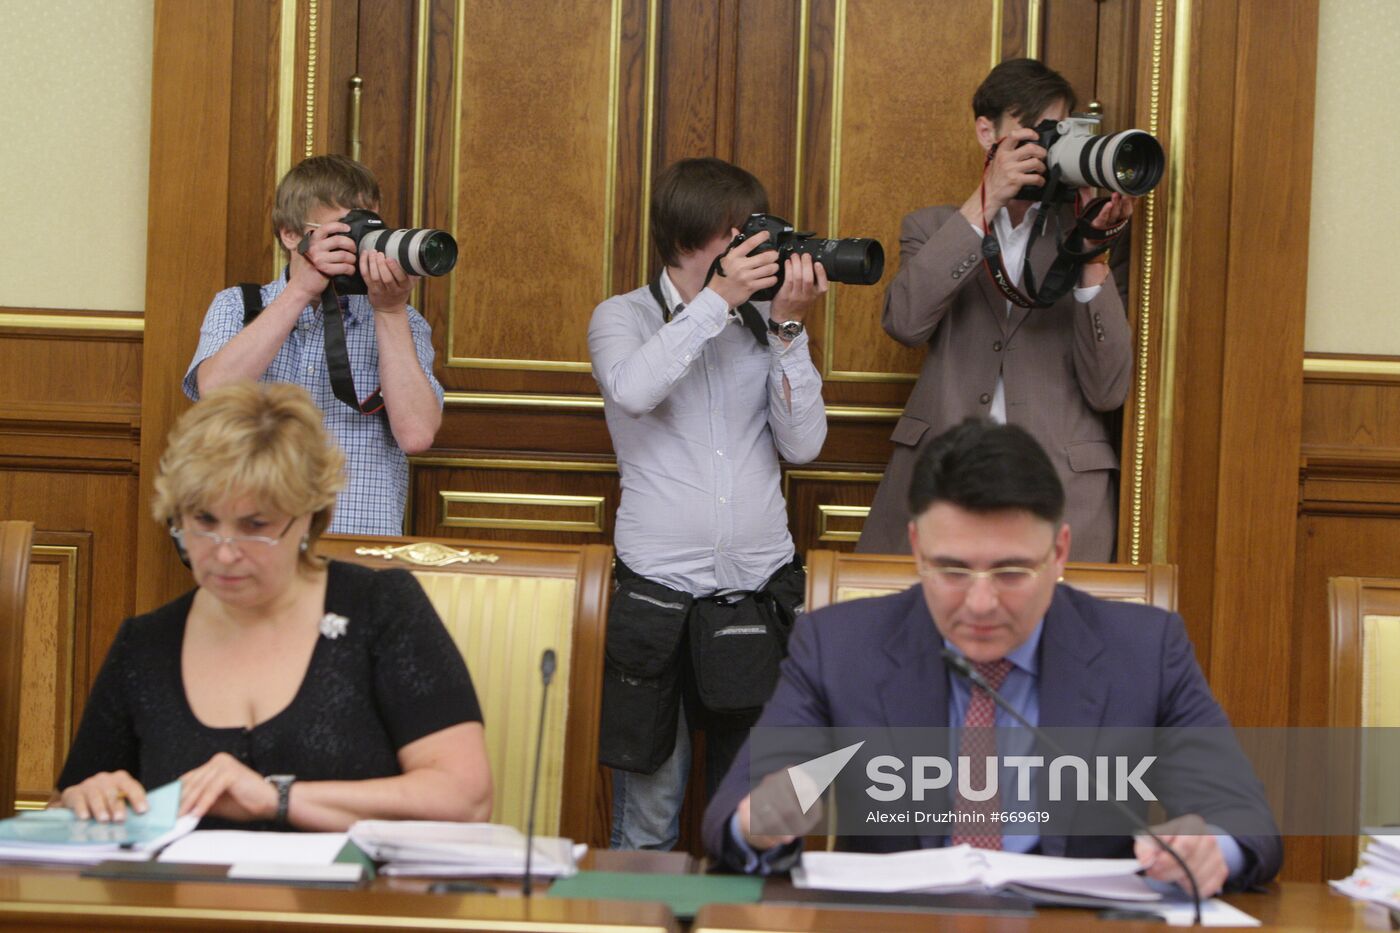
[447,0,616,370]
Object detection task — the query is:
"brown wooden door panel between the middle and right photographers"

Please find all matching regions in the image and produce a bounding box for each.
[802,0,1000,381]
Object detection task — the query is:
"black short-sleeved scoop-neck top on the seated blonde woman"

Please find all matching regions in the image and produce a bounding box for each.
[59,562,482,789]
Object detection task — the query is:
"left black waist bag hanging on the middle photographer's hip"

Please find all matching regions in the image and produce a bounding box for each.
[598,571,694,775]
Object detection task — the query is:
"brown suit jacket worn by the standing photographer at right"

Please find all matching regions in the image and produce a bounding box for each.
[857,206,1133,560]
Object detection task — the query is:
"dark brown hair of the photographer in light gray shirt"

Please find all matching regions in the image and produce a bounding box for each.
[651,158,769,266]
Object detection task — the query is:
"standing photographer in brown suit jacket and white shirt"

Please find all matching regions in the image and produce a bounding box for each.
[857,59,1135,560]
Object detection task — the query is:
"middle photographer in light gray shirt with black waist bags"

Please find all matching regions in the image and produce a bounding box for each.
[588,158,827,849]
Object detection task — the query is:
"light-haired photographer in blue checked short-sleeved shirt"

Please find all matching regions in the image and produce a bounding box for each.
[183,156,442,535]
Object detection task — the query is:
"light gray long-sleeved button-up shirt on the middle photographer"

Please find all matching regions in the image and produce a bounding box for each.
[588,275,826,595]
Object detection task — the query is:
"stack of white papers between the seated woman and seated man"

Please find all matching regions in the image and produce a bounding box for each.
[350,820,588,878]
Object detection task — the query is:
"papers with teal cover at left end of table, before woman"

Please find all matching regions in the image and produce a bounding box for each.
[0,780,199,864]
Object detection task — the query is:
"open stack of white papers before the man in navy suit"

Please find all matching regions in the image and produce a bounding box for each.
[792,846,1259,926]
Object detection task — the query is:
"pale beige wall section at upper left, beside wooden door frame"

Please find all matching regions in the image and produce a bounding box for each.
[0,0,154,311]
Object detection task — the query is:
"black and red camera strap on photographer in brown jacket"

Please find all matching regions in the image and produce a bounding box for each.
[981,140,1128,308]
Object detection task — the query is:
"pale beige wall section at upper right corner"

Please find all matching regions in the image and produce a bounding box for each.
[1299,0,1400,356]
